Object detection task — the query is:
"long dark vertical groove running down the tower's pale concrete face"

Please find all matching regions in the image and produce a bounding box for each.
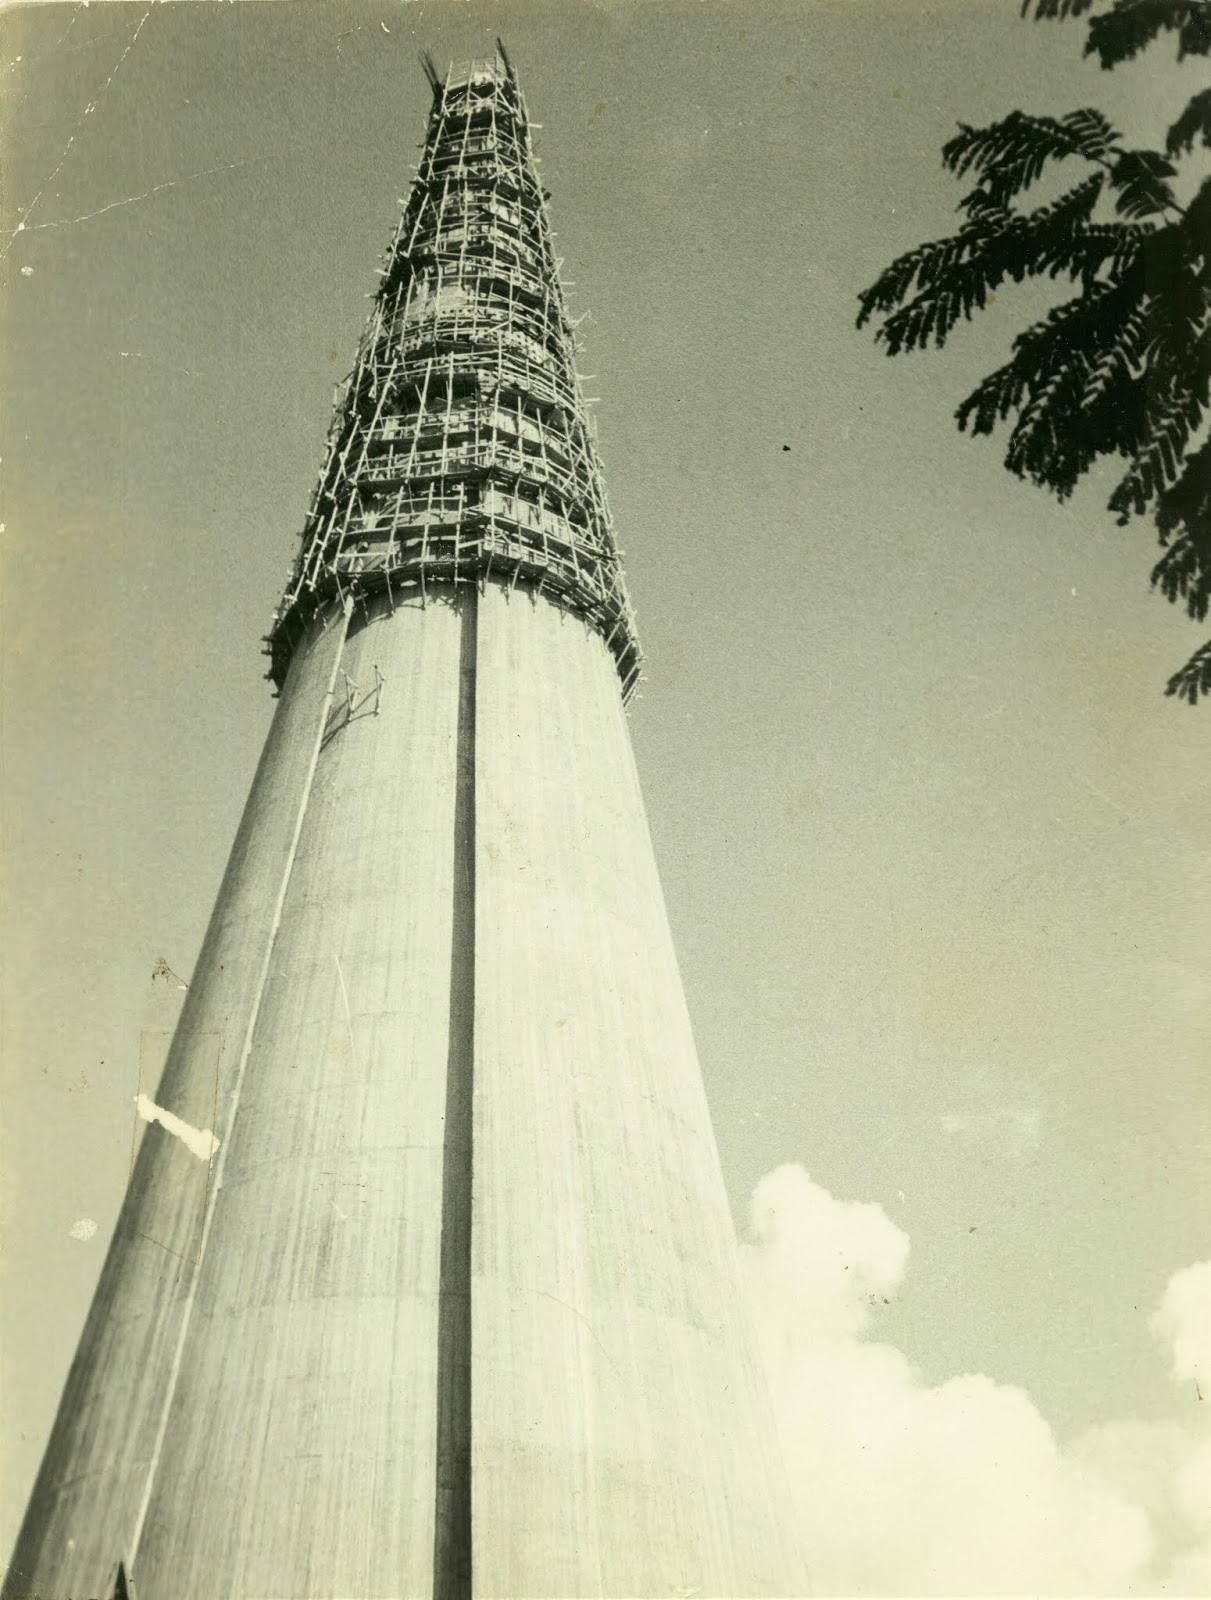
[434,586,478,1600]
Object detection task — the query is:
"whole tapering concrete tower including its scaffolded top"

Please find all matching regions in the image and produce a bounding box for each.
[3,51,803,1600]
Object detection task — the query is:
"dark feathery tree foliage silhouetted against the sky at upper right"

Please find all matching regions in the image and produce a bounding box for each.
[857,0,1211,704]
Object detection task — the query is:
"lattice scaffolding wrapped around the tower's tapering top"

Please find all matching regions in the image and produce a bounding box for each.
[266,48,640,698]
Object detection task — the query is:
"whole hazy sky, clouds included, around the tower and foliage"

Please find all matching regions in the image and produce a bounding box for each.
[0,0,1211,1594]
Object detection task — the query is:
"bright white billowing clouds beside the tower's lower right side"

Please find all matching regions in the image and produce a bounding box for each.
[742,1166,1211,1595]
